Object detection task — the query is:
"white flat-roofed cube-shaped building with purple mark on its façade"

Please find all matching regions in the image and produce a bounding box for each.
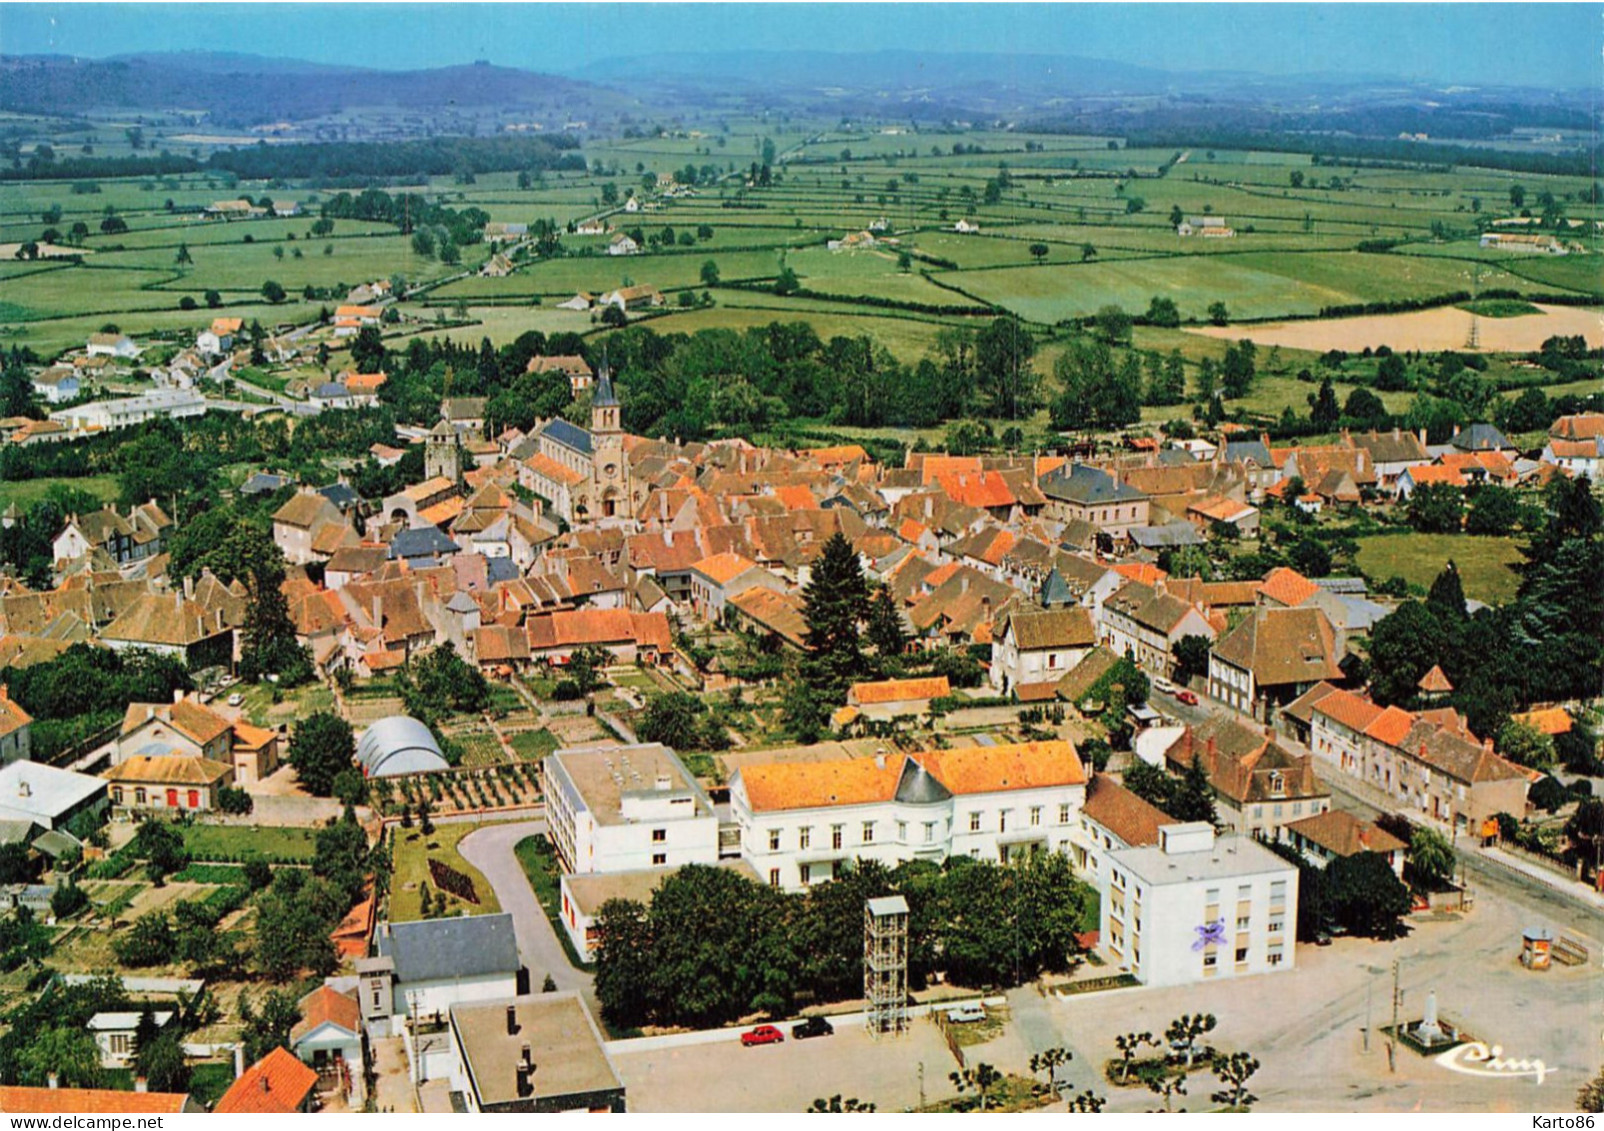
[1097,821,1298,985]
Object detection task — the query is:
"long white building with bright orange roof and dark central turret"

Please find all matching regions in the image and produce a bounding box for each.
[730,741,1086,890]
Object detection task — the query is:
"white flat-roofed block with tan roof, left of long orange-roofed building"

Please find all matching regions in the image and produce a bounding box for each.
[541,743,719,874]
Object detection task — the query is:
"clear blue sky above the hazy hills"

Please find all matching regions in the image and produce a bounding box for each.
[0,3,1604,87]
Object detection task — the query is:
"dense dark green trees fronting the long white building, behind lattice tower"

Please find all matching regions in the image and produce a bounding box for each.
[597,852,1097,1030]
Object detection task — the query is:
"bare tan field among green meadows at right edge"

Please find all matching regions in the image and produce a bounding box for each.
[1189,306,1604,353]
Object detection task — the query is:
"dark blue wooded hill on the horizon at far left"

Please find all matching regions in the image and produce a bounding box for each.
[0,51,629,125]
